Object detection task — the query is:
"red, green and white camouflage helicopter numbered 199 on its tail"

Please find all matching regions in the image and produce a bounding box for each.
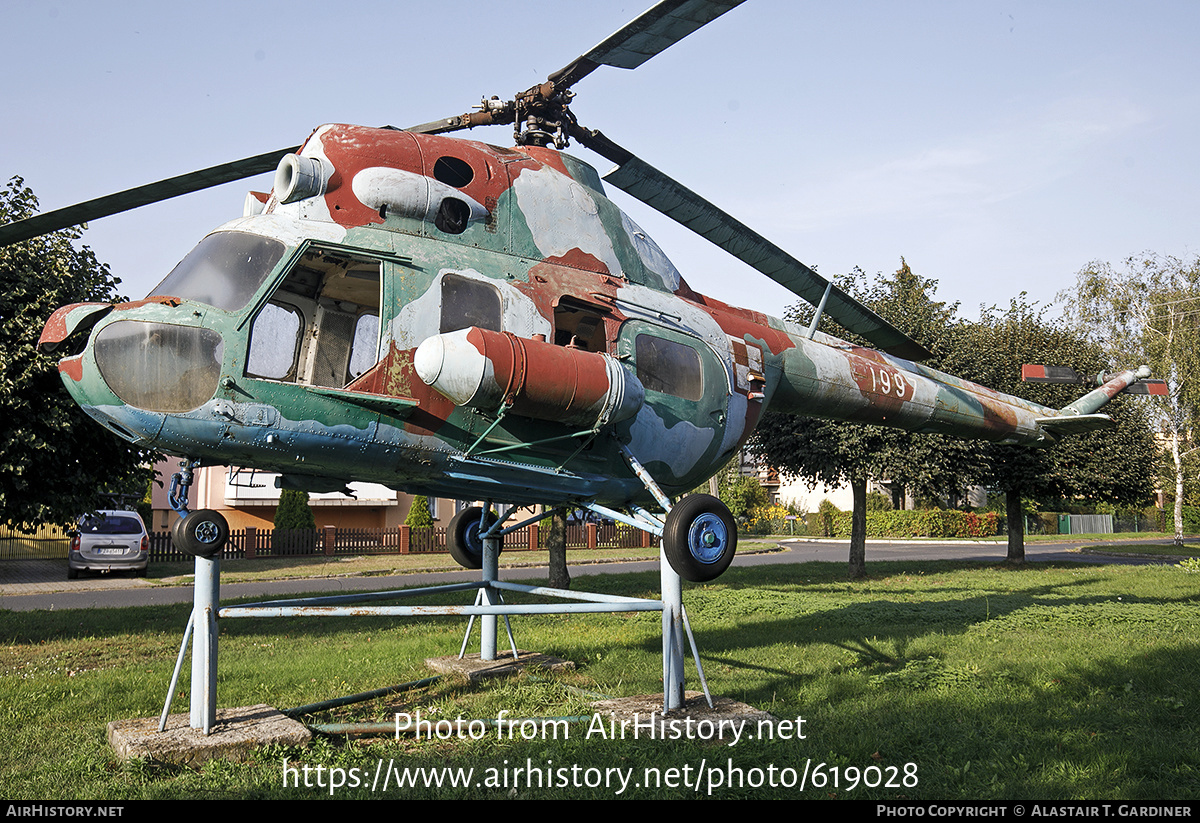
[0,0,1148,581]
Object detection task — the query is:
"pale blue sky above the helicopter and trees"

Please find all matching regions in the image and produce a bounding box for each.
[0,0,1200,326]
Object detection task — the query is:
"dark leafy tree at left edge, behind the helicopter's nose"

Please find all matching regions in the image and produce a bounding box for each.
[0,178,158,525]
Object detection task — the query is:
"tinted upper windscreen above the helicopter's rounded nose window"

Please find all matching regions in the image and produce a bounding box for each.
[149,232,284,311]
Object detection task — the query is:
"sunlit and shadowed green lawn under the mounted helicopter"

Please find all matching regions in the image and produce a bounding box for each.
[0,561,1200,800]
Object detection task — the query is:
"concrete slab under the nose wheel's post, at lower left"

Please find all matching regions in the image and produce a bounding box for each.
[108,705,312,767]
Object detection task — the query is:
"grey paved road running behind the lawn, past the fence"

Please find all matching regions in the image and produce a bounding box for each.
[0,540,1175,612]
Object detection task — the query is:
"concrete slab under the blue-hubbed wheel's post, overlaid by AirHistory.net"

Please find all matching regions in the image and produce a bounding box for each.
[592,691,777,743]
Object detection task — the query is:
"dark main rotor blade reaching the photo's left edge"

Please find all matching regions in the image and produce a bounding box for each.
[0,148,295,246]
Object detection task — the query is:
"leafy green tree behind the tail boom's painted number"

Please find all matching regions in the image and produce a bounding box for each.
[751,258,974,577]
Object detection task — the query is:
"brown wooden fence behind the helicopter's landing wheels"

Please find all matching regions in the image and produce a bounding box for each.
[150,522,658,560]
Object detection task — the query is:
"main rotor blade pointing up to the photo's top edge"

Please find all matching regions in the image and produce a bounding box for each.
[550,0,744,89]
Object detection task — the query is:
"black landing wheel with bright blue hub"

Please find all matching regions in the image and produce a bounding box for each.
[662,494,738,583]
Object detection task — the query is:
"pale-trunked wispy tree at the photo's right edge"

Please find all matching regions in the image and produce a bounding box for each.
[1060,253,1200,545]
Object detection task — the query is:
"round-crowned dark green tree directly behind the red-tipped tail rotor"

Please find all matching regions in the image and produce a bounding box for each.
[944,293,1154,563]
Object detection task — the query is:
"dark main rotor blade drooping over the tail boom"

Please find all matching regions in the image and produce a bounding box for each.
[572,128,932,360]
